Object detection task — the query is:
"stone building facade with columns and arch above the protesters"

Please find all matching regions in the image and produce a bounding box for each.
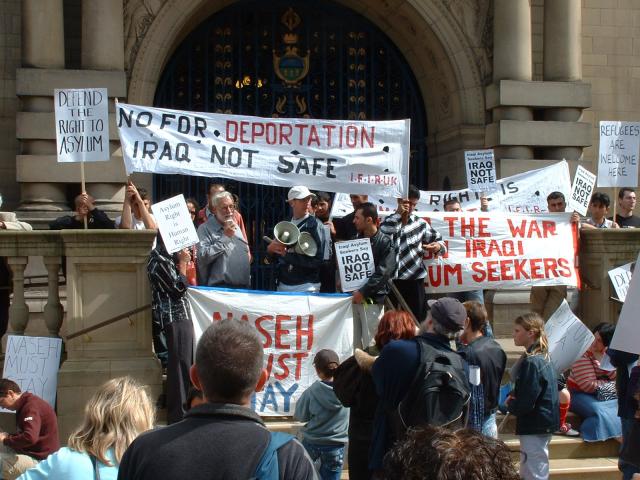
[0,0,640,224]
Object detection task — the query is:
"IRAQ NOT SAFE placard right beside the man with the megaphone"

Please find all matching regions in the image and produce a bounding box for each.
[335,238,375,292]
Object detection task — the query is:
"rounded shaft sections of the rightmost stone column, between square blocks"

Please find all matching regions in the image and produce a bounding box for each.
[543,0,582,160]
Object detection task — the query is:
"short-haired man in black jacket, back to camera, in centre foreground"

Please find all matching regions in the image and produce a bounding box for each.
[118,320,317,480]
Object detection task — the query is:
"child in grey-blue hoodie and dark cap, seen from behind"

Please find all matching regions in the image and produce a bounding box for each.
[294,349,349,480]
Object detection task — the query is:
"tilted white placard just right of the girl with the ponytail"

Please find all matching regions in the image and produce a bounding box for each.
[544,300,595,373]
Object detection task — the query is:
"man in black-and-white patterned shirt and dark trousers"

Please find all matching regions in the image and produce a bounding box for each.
[380,185,446,322]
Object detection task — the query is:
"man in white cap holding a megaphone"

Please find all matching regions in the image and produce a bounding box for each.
[267,185,324,292]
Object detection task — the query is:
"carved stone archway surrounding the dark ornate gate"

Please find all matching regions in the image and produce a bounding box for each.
[125,0,492,189]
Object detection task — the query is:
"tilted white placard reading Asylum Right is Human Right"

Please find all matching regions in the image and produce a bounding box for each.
[151,194,199,253]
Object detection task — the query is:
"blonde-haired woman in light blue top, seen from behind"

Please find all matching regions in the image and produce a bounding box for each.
[19,377,155,480]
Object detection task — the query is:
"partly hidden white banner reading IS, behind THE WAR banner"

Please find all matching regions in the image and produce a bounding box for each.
[331,160,571,217]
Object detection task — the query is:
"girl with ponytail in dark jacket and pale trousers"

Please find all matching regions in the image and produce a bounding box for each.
[507,313,560,480]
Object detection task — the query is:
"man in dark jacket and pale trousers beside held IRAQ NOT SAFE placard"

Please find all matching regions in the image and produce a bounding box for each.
[352,202,396,348]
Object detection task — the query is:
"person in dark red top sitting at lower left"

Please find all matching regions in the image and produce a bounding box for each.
[0,378,60,480]
